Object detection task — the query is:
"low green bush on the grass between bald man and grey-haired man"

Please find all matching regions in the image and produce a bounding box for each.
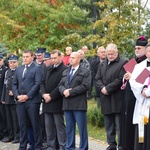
[87,107,104,127]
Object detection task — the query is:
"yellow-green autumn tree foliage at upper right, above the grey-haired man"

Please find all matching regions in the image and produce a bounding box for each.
[93,0,145,56]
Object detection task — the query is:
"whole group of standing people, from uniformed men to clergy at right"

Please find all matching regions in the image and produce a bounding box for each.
[0,36,150,150]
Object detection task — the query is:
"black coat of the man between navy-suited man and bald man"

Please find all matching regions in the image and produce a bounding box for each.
[41,63,67,113]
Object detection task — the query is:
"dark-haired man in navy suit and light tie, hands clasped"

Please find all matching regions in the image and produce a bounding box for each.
[12,50,43,150]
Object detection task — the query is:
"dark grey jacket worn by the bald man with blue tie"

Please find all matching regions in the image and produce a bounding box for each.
[59,66,91,110]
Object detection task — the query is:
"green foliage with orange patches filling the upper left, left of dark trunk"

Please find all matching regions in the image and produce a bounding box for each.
[0,0,87,51]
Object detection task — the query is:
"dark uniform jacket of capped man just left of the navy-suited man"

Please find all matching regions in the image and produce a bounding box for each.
[1,69,16,104]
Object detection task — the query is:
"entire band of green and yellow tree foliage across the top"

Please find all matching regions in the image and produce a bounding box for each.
[0,0,148,57]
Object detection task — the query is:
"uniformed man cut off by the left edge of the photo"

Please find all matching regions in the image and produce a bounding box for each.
[0,55,8,140]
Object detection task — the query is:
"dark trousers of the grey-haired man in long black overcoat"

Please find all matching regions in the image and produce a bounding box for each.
[104,113,121,147]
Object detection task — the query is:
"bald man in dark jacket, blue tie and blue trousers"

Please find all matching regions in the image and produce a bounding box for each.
[59,52,91,150]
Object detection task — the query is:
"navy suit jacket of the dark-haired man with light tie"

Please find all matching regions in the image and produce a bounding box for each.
[12,62,43,103]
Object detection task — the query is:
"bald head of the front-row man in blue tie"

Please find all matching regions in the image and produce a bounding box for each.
[70,52,81,68]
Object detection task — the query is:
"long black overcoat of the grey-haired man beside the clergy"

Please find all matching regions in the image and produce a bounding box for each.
[96,55,127,114]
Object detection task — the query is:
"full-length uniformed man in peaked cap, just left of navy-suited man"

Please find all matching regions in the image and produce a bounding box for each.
[1,55,19,143]
